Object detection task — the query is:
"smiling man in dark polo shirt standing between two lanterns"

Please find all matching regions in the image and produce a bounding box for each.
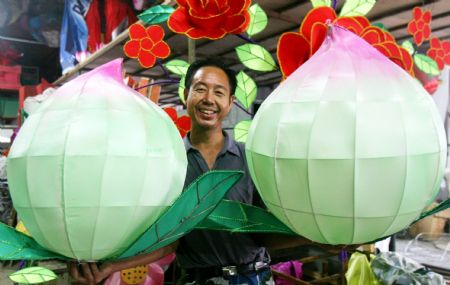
[69,60,312,285]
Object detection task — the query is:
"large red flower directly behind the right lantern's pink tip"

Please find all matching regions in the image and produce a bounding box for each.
[277,6,414,78]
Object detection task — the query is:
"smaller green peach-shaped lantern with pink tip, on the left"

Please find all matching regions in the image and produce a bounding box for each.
[7,59,187,260]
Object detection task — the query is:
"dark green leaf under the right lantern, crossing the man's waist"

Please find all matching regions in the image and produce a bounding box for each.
[195,200,296,235]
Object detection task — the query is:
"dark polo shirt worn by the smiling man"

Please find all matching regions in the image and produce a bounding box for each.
[177,132,268,269]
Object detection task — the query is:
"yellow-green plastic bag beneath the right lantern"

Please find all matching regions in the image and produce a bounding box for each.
[345,252,381,285]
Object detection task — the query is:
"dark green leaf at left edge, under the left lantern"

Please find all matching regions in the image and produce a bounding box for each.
[0,223,67,260]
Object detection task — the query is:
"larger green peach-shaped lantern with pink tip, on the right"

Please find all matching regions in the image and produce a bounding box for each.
[246,26,447,244]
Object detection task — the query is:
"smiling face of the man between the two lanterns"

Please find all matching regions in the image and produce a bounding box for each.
[185,66,233,129]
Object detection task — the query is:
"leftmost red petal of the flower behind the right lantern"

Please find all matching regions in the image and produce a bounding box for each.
[277,32,310,78]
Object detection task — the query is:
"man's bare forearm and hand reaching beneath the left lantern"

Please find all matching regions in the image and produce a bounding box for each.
[67,241,178,285]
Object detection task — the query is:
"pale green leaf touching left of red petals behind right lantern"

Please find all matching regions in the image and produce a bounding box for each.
[236,44,277,71]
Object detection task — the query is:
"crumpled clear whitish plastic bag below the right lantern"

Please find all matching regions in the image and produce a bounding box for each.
[371,252,445,285]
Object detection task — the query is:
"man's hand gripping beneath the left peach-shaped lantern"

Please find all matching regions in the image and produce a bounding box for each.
[67,261,113,285]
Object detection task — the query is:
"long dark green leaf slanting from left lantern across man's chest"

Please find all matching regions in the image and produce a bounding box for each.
[119,170,243,258]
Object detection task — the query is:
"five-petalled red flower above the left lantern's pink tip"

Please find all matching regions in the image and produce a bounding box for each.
[123,23,170,68]
